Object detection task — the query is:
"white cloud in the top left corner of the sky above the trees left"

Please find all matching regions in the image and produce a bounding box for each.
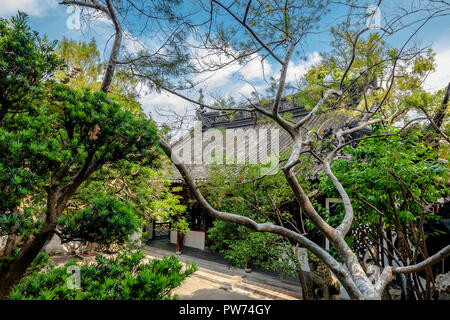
[0,0,58,17]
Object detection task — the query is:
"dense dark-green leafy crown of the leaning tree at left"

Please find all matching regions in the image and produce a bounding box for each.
[0,80,158,212]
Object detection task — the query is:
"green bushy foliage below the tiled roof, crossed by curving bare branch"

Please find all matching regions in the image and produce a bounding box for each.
[205,156,310,274]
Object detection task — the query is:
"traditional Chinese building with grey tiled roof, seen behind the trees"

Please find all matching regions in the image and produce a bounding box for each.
[155,99,450,280]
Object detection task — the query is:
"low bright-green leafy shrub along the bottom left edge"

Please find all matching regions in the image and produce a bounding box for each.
[9,251,196,300]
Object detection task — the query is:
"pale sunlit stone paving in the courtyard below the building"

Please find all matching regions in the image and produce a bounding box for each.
[144,241,302,300]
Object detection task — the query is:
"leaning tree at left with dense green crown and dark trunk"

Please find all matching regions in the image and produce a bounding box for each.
[0,84,159,296]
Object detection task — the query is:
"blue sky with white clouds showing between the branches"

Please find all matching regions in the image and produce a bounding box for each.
[0,0,450,127]
